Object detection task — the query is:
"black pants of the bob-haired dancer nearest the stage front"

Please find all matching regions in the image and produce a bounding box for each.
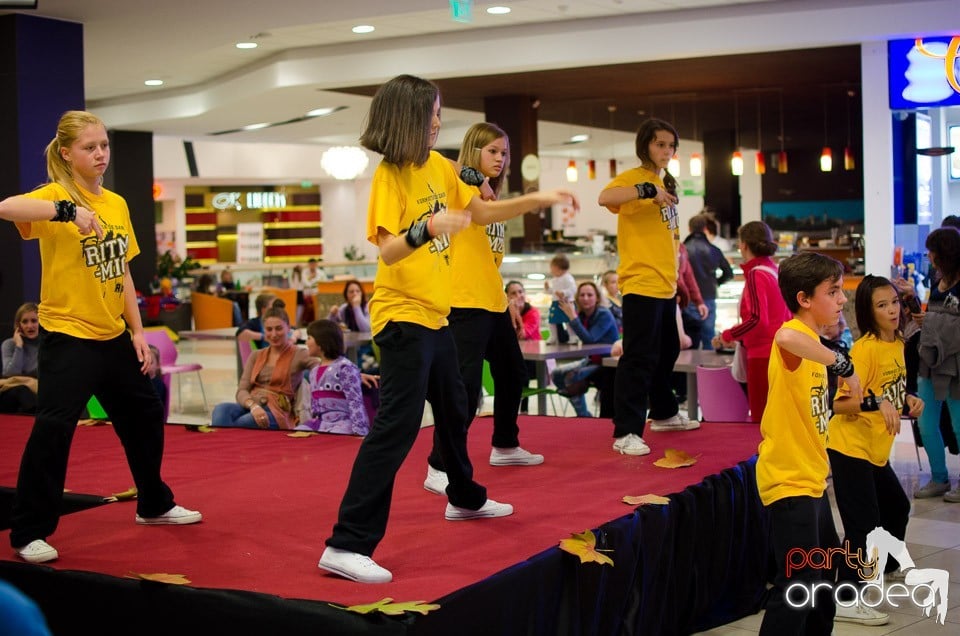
[327,322,487,556]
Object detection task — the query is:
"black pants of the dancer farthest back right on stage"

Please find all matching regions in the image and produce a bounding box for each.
[613,294,680,437]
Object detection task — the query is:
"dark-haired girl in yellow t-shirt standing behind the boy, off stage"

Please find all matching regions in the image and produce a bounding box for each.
[827,276,923,623]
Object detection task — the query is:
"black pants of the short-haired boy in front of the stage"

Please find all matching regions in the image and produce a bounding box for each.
[760,493,839,636]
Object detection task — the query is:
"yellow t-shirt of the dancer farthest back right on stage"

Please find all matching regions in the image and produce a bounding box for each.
[604,168,680,298]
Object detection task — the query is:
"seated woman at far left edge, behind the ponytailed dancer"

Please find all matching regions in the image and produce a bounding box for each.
[0,303,40,414]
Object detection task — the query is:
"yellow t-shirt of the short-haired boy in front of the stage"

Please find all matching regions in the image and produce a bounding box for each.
[757,318,830,506]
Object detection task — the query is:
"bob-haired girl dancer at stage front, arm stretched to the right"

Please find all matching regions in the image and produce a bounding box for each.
[319,75,578,583]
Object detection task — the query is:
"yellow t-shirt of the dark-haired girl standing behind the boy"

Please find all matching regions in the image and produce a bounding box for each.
[827,335,907,466]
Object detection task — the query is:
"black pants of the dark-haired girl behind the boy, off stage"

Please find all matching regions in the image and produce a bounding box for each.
[827,449,910,583]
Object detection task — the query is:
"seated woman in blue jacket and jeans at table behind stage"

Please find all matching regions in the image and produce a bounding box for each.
[553,282,620,417]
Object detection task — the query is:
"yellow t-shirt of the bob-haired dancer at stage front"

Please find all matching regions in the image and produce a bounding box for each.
[367,152,473,334]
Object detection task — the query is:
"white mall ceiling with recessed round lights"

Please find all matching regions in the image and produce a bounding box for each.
[0,0,785,153]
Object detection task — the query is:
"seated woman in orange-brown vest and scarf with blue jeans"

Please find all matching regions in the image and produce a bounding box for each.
[210,306,319,429]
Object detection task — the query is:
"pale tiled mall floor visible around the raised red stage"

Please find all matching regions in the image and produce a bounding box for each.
[170,340,960,636]
